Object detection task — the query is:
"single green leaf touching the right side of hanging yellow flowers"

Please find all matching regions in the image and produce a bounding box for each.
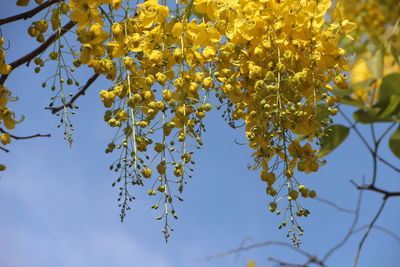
[318,124,350,158]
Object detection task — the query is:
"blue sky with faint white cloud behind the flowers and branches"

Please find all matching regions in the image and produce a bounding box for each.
[0,1,400,267]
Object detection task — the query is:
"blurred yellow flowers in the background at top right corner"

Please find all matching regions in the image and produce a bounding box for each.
[338,0,400,107]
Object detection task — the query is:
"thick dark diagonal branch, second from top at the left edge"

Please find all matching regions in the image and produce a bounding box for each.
[0,21,75,84]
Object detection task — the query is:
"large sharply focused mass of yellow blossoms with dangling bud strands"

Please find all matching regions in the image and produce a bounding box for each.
[4,0,355,243]
